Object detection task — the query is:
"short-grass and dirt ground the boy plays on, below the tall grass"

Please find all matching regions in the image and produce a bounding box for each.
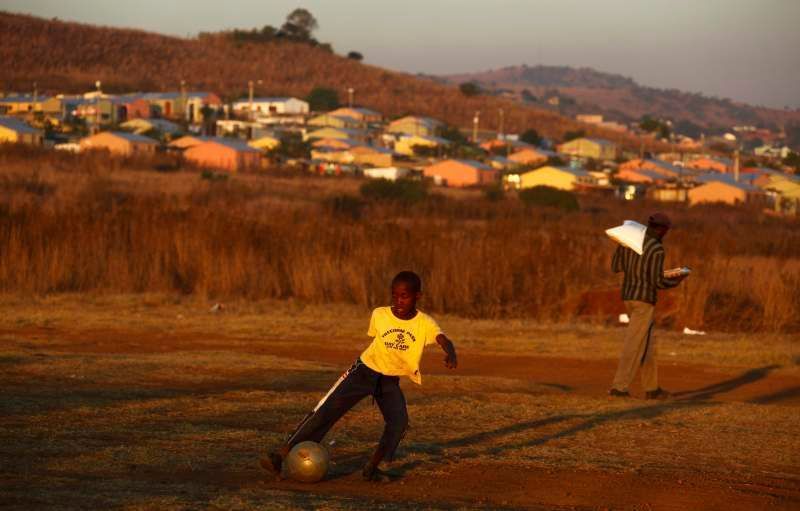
[0,296,800,510]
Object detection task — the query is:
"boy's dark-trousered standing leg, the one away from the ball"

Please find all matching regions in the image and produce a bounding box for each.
[363,376,408,479]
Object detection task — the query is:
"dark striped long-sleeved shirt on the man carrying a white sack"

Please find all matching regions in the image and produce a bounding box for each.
[611,232,679,305]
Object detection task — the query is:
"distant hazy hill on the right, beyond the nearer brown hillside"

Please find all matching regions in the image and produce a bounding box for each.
[442,66,800,135]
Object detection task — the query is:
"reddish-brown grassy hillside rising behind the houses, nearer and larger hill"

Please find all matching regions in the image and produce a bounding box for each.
[0,12,656,147]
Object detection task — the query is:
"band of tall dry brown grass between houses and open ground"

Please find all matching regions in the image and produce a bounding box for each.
[0,147,800,331]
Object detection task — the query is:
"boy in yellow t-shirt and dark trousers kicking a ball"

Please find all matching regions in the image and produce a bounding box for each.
[261,271,458,481]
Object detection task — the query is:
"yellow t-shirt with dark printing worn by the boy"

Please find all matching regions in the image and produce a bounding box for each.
[361,307,442,385]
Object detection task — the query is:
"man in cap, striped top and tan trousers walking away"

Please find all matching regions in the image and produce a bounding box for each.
[608,213,685,399]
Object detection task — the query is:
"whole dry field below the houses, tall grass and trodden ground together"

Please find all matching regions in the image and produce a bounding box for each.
[0,148,800,510]
